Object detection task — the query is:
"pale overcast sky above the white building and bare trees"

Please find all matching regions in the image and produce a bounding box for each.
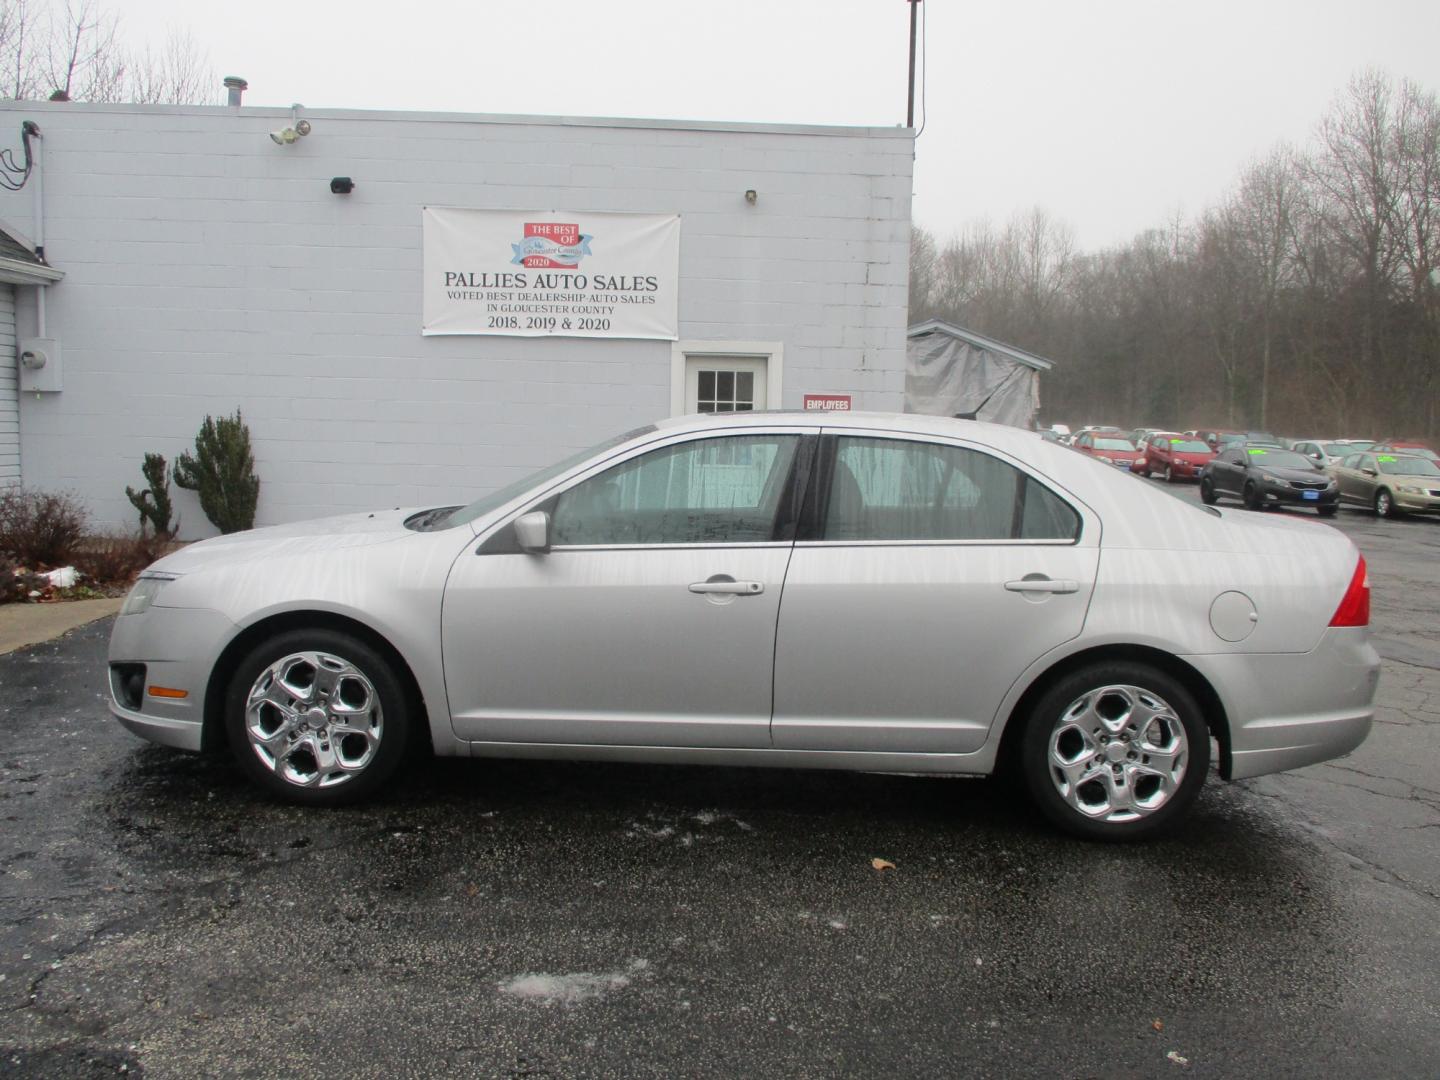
[112,0,1440,248]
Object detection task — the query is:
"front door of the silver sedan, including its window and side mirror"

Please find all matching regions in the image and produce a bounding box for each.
[442,429,802,747]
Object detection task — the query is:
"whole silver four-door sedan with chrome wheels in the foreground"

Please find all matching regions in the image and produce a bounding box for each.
[109,413,1378,840]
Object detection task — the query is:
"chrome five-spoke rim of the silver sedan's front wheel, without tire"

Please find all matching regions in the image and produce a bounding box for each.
[245,652,384,788]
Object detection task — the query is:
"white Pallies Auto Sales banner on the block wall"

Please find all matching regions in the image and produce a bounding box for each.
[422,206,680,340]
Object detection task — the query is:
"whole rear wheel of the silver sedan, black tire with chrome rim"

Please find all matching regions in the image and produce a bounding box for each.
[1020,661,1210,841]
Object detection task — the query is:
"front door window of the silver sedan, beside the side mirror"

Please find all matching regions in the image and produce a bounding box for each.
[550,435,799,547]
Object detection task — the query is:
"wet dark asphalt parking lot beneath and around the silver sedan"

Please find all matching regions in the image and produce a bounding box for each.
[0,481,1440,1077]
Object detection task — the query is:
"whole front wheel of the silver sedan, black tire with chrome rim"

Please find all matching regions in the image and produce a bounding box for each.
[225,628,413,806]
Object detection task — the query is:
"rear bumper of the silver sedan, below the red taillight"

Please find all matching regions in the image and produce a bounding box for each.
[1185,626,1380,780]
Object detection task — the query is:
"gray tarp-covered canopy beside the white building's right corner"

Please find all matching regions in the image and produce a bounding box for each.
[904,318,1054,428]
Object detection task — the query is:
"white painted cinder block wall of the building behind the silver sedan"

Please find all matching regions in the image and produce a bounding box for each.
[0,102,913,537]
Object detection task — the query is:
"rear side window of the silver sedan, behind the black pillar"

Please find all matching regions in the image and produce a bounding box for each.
[822,438,1080,540]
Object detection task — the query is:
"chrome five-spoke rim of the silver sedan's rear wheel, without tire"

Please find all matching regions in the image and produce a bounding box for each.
[1047,685,1189,822]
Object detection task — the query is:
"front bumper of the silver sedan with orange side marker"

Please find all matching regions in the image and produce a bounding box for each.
[107,605,239,750]
